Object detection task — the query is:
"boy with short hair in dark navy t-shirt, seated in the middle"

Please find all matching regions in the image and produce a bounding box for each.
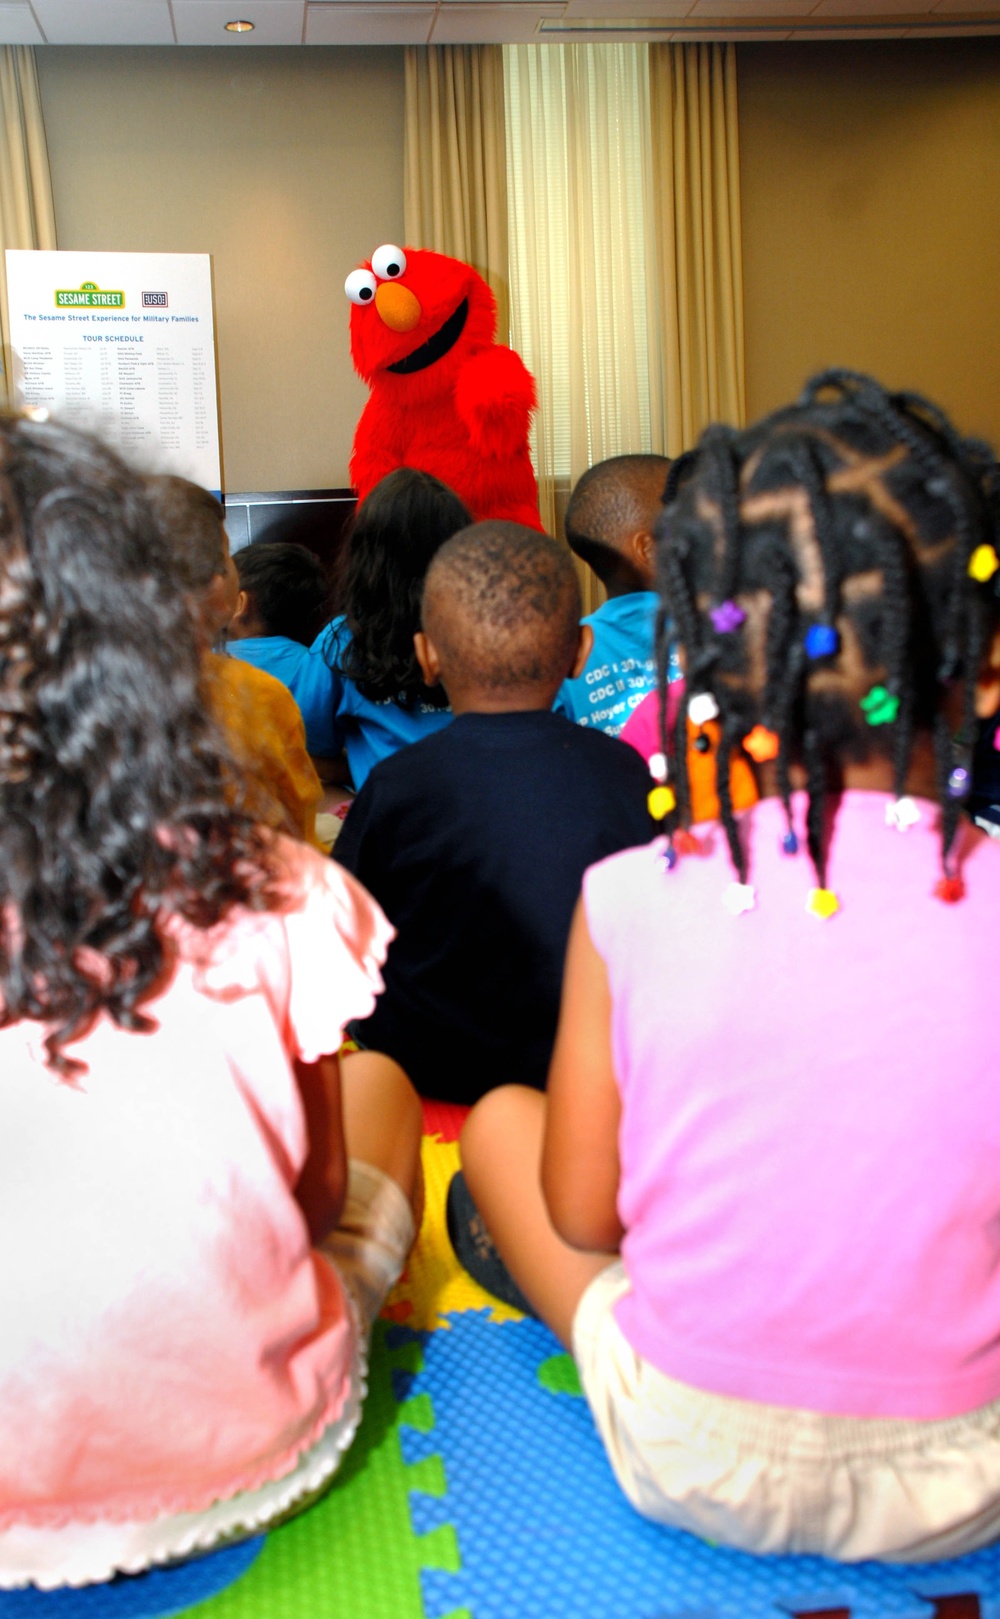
[335,521,652,1103]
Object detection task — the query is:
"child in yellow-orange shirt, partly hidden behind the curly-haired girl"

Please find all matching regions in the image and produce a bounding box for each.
[147,476,322,843]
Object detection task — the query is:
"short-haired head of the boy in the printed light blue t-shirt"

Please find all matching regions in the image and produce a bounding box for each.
[565,455,670,588]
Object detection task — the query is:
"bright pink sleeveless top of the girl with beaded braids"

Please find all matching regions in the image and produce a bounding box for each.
[584,792,1000,1418]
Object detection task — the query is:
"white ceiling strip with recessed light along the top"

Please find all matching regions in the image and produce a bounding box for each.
[0,0,1000,50]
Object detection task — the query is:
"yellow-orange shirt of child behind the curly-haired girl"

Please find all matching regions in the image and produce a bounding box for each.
[202,652,322,847]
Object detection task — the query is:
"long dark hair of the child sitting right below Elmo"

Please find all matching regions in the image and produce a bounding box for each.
[337,466,472,708]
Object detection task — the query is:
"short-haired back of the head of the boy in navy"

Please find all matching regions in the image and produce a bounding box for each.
[422,521,581,691]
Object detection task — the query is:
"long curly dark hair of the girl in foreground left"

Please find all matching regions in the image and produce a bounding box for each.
[0,416,273,1077]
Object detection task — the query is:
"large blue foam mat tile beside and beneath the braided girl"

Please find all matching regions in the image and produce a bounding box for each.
[405,1311,1000,1619]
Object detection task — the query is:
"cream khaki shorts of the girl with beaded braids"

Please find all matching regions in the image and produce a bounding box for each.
[573,1261,1000,1562]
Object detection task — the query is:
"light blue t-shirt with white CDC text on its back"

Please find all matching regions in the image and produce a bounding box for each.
[552,591,680,737]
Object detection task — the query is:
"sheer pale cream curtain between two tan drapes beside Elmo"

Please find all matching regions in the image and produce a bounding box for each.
[503,44,652,553]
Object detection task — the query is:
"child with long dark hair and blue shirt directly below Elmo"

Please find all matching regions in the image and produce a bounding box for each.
[312,466,469,788]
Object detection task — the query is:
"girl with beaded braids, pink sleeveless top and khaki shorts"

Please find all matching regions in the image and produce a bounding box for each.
[461,372,1000,1561]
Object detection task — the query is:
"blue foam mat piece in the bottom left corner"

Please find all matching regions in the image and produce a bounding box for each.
[0,1535,264,1619]
